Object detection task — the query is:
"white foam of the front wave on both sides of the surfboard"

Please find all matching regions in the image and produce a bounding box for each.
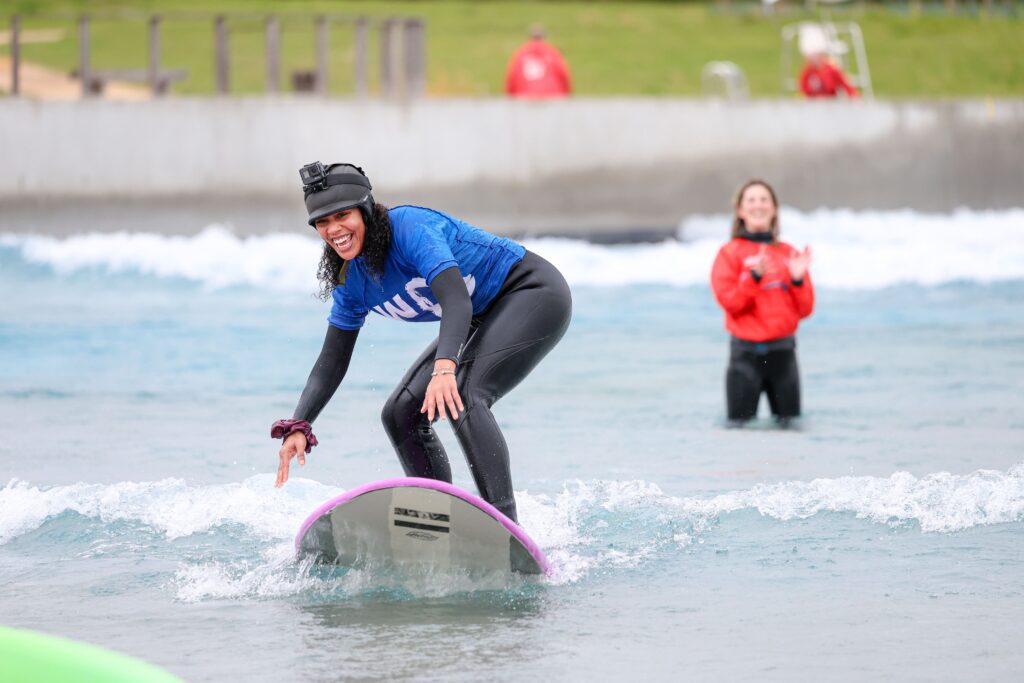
[0,463,1024,601]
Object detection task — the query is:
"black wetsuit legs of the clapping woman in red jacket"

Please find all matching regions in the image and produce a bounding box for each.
[725,337,800,423]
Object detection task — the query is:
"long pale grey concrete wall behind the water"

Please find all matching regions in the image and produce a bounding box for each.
[0,98,1024,239]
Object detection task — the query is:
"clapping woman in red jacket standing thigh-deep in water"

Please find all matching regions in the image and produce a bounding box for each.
[711,180,814,426]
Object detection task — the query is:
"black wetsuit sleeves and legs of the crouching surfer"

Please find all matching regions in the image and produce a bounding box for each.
[294,251,572,520]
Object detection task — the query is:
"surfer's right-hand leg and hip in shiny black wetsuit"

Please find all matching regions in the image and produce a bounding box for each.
[452,252,572,520]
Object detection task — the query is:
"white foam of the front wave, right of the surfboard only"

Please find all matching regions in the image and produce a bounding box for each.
[532,464,1024,584]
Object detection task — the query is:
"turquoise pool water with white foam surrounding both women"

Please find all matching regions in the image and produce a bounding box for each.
[0,212,1024,681]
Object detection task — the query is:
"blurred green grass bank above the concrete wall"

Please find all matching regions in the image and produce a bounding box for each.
[6,0,1024,97]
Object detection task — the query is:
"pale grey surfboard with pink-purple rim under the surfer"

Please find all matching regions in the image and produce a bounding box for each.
[295,477,550,574]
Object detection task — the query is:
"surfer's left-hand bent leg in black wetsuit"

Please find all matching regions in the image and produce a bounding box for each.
[381,340,452,483]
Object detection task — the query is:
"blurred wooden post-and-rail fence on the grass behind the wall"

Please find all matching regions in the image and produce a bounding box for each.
[5,11,426,98]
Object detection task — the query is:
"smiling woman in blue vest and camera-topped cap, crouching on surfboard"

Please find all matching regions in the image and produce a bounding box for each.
[271,162,572,520]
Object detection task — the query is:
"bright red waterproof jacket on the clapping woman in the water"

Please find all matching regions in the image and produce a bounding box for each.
[711,238,814,342]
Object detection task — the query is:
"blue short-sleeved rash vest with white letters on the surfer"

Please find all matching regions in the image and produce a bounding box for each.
[327,206,526,330]
